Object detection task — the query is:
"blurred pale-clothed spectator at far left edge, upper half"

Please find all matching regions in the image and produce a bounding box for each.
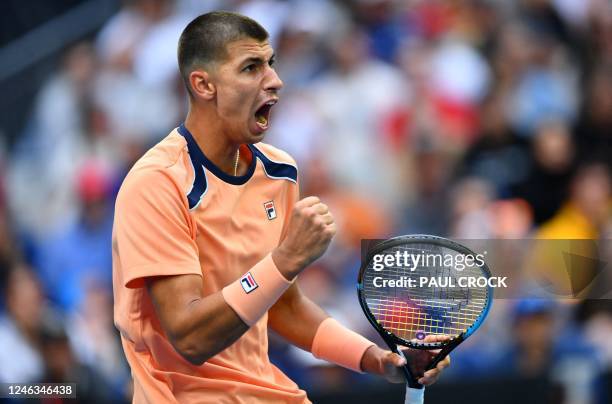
[7,43,97,236]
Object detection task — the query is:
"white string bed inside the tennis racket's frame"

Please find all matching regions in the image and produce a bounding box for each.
[363,244,489,341]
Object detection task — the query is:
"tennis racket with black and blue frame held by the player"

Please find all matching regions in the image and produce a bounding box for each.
[357,235,493,404]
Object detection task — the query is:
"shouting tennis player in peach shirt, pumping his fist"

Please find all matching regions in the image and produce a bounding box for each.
[113,12,449,403]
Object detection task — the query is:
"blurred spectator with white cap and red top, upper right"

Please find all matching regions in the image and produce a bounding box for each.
[396,30,490,152]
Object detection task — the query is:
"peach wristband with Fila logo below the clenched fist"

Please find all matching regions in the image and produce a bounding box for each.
[221,254,295,326]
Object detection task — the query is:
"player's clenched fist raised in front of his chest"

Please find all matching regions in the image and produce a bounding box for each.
[272,196,336,280]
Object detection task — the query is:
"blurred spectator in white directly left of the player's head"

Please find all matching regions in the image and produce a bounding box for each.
[93,0,186,144]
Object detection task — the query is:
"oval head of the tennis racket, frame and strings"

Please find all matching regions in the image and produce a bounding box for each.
[357,234,493,349]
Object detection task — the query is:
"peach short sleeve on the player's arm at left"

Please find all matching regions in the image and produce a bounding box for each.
[113,170,202,288]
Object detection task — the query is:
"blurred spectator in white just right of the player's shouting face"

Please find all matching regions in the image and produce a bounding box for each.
[309,26,405,211]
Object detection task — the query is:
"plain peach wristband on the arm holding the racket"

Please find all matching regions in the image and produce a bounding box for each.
[312,317,375,373]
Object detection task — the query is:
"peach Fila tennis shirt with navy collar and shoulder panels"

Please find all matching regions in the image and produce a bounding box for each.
[113,125,309,403]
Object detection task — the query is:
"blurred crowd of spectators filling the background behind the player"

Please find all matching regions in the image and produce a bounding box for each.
[0,0,612,403]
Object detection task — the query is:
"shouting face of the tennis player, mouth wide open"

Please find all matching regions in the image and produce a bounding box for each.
[211,38,283,143]
